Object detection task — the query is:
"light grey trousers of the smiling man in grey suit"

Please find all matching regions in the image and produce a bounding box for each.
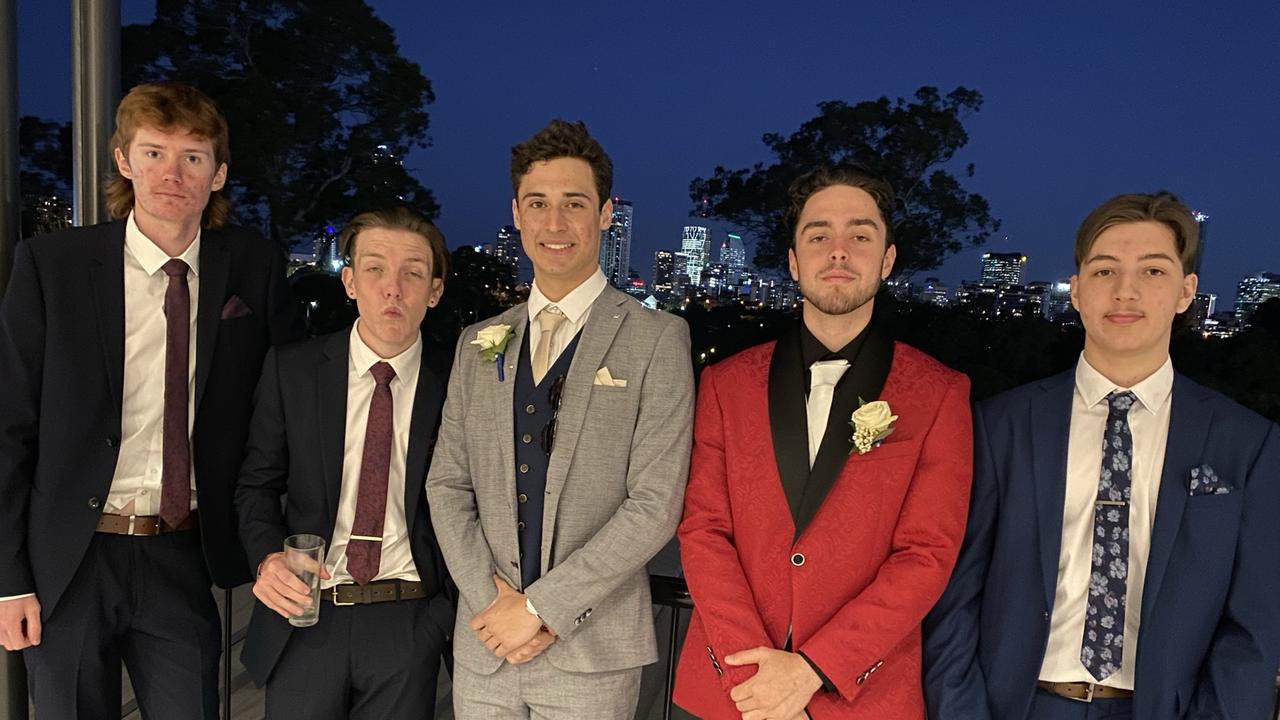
[453,655,641,720]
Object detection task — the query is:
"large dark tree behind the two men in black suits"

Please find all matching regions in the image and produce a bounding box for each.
[122,0,439,245]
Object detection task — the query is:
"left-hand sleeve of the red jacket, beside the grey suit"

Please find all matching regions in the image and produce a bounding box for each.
[680,366,773,691]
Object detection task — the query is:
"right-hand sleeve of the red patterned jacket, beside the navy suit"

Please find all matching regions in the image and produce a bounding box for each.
[796,375,973,701]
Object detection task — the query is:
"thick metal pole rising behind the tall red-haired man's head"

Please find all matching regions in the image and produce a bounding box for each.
[72,0,120,225]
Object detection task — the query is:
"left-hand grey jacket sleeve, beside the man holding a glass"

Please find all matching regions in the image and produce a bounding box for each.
[426,332,498,609]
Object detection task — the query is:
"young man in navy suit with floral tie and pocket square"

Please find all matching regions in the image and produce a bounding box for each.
[924,192,1280,720]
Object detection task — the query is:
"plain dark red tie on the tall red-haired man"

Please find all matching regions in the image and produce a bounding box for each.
[160,260,191,528]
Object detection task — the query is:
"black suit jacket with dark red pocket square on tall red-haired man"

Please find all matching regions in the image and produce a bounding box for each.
[0,222,296,609]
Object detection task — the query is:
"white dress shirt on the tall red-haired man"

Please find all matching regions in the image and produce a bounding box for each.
[105,213,200,515]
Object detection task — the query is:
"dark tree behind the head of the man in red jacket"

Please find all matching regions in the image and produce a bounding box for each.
[689,87,1000,274]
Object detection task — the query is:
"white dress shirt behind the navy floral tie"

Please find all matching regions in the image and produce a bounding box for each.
[1039,355,1174,691]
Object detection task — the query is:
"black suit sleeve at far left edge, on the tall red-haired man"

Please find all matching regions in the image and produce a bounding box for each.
[0,241,45,597]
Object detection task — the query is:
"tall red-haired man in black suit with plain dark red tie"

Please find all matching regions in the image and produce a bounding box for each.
[0,83,293,719]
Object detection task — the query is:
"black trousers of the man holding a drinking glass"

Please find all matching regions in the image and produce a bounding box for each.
[266,600,445,720]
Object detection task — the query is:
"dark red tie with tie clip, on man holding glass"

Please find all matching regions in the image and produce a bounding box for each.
[347,363,396,584]
